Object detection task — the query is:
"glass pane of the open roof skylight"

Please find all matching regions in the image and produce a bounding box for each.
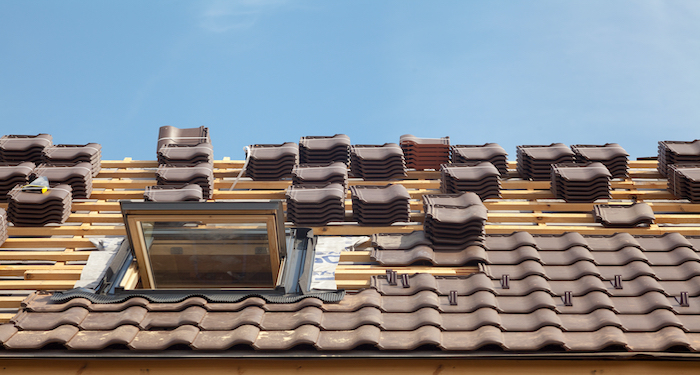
[139,221,276,288]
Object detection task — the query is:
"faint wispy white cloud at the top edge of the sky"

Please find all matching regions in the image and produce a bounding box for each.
[200,0,287,33]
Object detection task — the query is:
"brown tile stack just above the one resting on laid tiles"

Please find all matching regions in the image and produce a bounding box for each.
[440,161,501,199]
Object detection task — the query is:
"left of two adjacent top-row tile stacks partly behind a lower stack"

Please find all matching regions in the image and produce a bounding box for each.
[517,143,574,181]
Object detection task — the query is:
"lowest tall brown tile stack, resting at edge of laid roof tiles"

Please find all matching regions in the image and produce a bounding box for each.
[423,193,487,250]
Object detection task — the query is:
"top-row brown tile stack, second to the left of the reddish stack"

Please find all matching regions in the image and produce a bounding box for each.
[299,134,350,165]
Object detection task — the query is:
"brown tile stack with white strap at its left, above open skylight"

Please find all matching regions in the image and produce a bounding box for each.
[246,142,299,181]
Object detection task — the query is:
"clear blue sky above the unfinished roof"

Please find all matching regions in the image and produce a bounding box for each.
[0,0,700,160]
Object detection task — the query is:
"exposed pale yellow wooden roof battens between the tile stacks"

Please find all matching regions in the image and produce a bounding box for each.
[0,158,700,320]
